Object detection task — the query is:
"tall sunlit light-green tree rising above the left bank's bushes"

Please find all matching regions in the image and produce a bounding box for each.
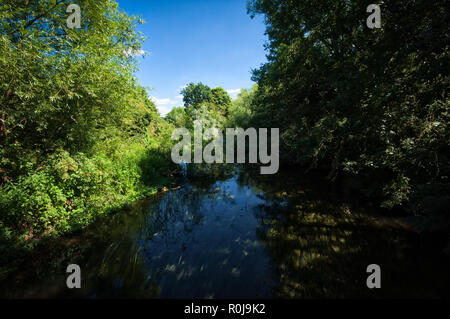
[0,0,146,172]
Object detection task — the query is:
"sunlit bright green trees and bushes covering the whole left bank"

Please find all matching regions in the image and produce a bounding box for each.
[0,0,171,276]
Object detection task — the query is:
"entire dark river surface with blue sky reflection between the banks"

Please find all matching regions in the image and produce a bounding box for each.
[0,168,450,298]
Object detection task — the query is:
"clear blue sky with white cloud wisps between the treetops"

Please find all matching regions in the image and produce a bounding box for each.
[118,0,266,115]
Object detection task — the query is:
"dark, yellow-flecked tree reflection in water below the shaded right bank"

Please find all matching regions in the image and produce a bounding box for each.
[241,173,449,298]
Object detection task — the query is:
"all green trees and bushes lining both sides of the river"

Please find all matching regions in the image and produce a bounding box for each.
[0,0,450,288]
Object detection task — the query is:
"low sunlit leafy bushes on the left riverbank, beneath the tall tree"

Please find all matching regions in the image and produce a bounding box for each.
[0,136,179,281]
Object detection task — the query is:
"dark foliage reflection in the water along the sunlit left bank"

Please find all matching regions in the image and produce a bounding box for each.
[0,203,158,298]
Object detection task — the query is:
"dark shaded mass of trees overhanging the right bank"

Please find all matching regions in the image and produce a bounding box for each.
[244,0,450,213]
